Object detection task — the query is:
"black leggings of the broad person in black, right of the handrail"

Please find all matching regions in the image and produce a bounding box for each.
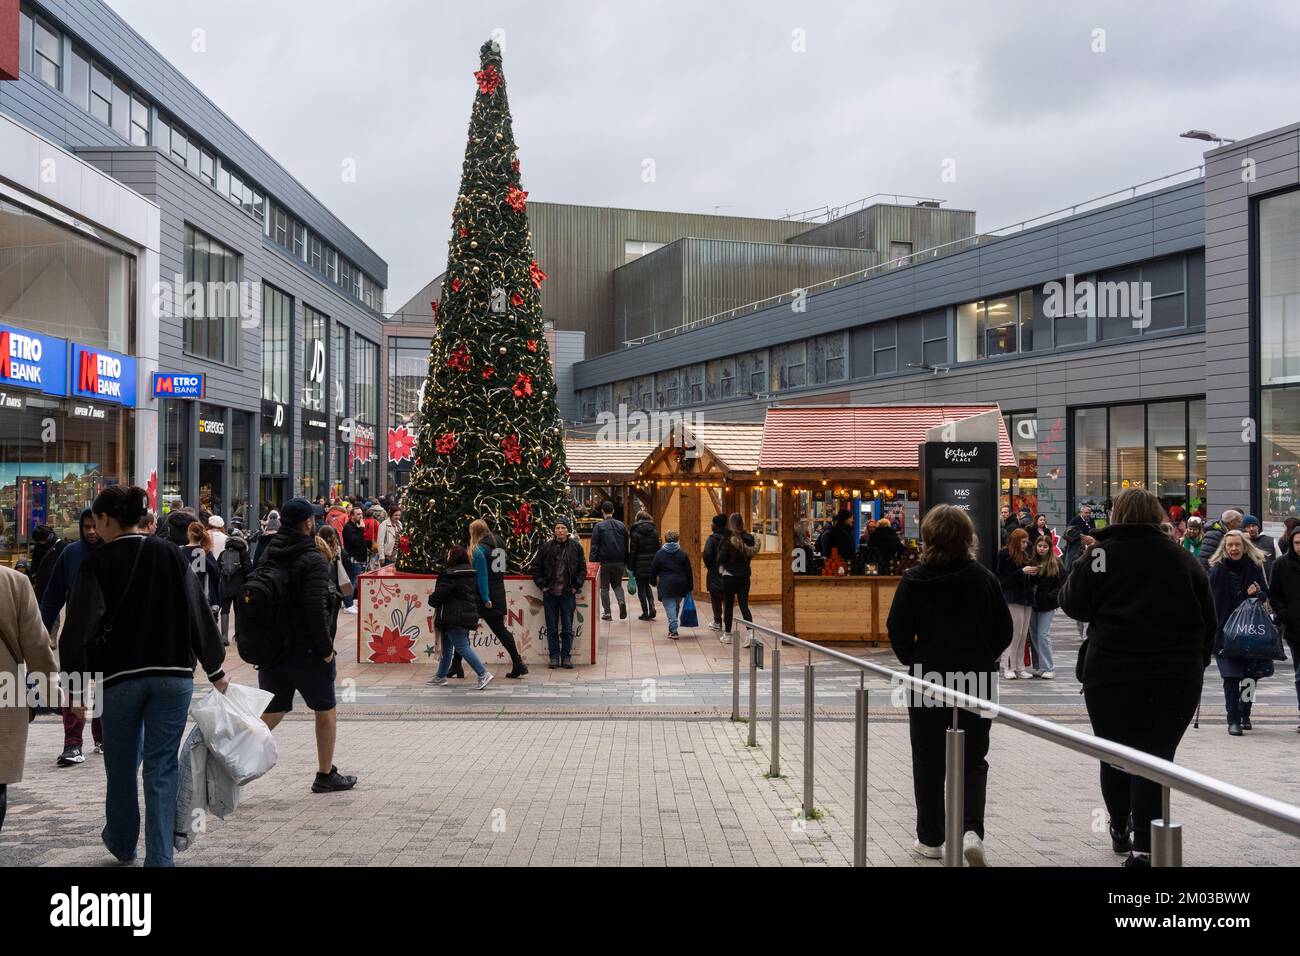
[1083,680,1201,853]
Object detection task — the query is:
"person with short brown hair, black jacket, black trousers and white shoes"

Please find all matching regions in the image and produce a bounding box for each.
[887,505,1011,866]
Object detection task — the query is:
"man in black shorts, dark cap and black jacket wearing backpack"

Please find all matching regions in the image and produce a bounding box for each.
[257,498,356,793]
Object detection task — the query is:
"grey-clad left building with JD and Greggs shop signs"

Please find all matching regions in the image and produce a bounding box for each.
[0,0,387,522]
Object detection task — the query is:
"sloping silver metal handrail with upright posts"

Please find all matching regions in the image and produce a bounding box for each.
[732,620,1300,866]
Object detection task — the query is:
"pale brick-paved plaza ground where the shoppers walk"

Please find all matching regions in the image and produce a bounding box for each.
[0,609,1300,866]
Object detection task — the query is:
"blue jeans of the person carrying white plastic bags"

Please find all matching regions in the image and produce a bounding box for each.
[101,678,194,866]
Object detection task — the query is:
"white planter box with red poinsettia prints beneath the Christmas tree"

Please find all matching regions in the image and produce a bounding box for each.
[356,564,598,669]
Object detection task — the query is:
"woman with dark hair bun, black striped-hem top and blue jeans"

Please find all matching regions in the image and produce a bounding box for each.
[59,485,228,866]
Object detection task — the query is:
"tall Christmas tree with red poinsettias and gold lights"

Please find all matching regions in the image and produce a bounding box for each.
[398,42,572,572]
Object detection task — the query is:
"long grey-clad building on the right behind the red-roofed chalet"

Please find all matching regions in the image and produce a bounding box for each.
[575,156,1268,528]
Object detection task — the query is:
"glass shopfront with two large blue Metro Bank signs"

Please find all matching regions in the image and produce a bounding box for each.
[0,199,137,564]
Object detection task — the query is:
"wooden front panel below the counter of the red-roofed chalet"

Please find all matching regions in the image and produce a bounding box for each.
[794,575,900,644]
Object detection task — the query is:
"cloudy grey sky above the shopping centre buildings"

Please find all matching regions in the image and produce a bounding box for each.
[111,0,1300,310]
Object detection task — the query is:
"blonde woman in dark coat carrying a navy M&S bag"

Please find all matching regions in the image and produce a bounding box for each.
[1210,531,1273,737]
